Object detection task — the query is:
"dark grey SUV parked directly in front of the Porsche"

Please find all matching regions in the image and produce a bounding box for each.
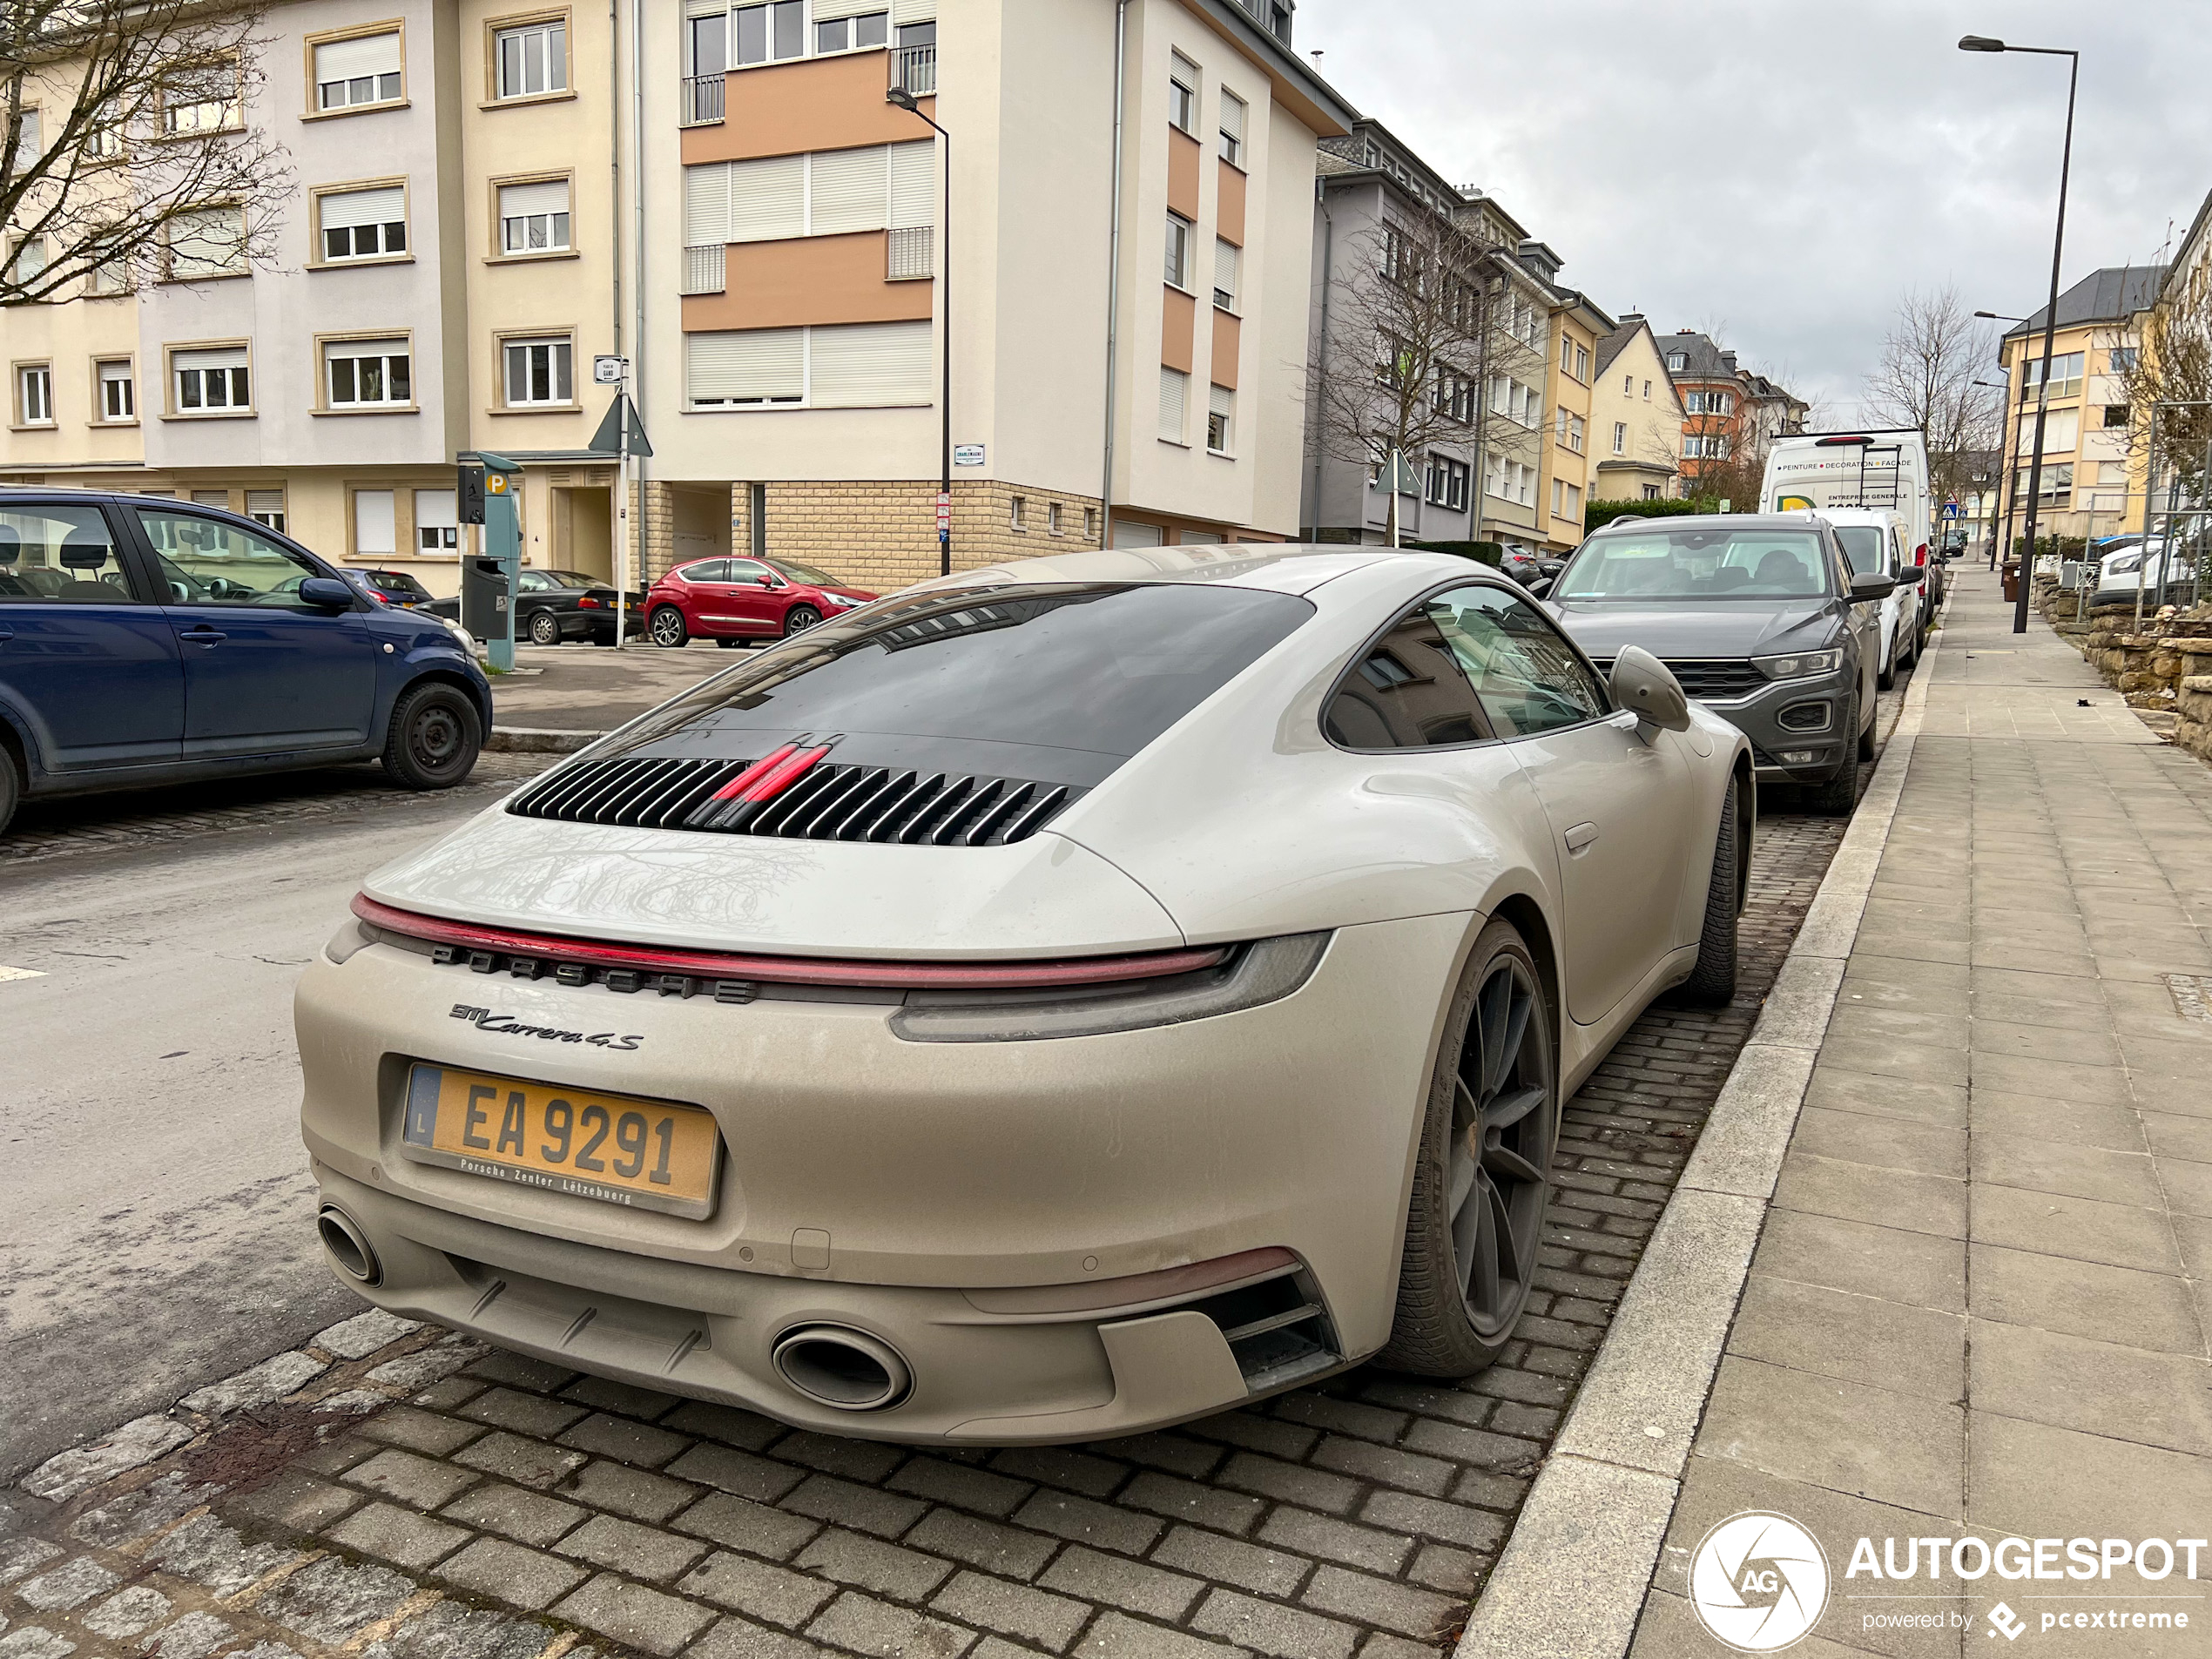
[1544,513,1898,812]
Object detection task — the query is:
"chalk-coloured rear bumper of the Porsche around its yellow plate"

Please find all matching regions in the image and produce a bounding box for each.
[299,916,1471,1442]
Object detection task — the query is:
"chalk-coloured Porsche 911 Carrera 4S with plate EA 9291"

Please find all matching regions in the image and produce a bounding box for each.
[299,546,1754,1445]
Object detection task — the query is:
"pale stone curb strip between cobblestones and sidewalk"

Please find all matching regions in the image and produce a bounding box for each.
[1453,602,1949,1659]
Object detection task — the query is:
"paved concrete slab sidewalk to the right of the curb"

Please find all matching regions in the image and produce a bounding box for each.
[1633,570,2212,1659]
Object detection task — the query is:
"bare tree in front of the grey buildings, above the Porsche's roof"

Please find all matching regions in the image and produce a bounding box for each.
[1307,210,1541,542]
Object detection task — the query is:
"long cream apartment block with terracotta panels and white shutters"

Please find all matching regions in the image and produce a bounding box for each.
[0,0,1352,590]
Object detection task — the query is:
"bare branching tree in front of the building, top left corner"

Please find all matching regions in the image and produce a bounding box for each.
[0,0,292,307]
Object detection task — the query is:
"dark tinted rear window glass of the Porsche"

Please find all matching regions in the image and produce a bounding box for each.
[605,584,1314,787]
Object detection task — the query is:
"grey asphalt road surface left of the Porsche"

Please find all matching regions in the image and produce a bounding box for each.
[0,787,506,1482]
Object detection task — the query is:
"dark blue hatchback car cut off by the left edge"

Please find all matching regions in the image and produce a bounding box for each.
[0,489,491,830]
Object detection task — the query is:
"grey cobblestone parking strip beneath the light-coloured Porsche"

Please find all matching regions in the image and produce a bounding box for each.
[0,677,1893,1659]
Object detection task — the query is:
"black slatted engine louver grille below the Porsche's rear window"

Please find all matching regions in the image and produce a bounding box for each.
[509,757,1084,847]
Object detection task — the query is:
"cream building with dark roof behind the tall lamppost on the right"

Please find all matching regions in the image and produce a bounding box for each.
[1998,266,2168,537]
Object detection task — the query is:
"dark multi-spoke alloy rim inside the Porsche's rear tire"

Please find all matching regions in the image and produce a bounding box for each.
[1445,958,1555,1340]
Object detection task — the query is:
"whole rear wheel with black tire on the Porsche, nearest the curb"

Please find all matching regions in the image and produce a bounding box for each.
[1376,918,1560,1376]
